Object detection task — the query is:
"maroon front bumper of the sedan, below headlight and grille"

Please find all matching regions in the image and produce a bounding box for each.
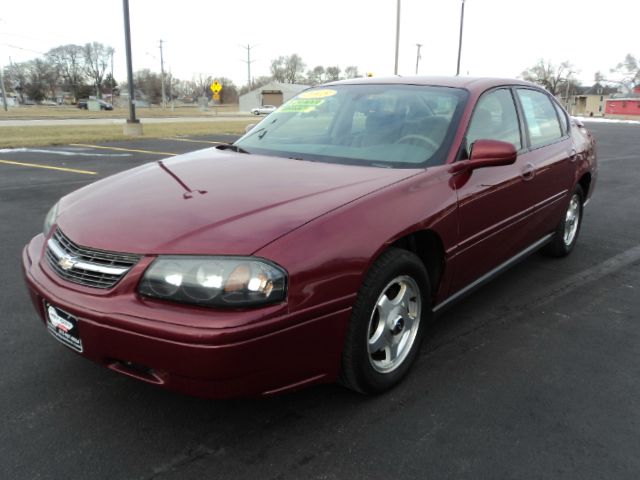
[23,235,351,398]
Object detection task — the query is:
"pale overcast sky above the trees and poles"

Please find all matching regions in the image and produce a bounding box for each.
[0,0,640,86]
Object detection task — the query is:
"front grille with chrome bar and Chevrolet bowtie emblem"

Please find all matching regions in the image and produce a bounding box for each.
[46,229,141,288]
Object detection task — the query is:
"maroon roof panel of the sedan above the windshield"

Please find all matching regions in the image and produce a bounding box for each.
[326,75,540,91]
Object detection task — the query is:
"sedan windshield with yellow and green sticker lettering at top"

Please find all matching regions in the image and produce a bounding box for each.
[234,85,467,168]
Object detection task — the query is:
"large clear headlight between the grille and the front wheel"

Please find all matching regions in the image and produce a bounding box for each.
[138,256,287,308]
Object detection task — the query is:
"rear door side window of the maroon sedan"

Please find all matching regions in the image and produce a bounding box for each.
[518,88,563,147]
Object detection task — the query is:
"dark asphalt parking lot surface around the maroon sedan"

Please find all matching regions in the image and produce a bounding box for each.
[0,123,640,480]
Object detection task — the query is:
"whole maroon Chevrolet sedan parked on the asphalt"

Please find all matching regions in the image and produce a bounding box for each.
[23,78,597,397]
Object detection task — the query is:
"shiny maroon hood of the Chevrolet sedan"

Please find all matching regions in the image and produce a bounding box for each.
[57,149,420,255]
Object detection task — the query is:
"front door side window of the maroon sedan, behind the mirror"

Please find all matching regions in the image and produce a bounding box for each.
[467,88,522,150]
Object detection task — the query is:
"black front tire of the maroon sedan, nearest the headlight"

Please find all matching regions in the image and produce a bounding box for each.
[340,248,432,394]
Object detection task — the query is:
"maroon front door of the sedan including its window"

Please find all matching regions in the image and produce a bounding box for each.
[450,87,535,294]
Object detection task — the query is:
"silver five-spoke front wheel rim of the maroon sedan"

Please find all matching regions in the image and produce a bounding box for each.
[367,275,422,373]
